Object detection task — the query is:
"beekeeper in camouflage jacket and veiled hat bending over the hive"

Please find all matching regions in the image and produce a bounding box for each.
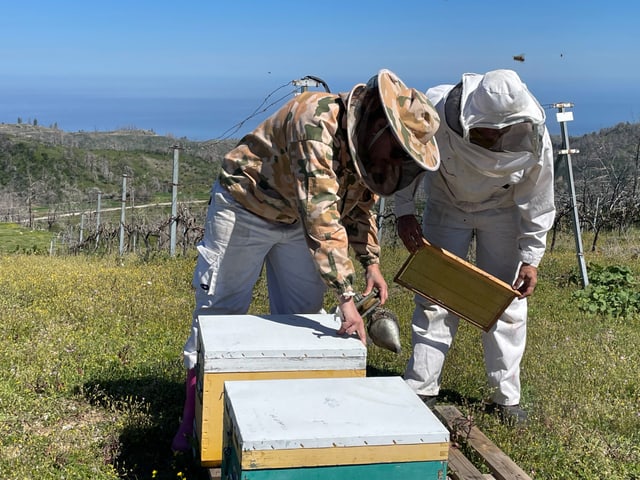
[173,70,439,450]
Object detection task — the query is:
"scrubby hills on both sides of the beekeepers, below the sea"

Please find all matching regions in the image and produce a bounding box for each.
[0,119,640,232]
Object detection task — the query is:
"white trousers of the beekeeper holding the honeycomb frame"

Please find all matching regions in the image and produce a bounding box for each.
[404,203,527,405]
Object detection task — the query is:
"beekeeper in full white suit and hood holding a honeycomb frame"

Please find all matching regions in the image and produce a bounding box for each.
[395,70,555,423]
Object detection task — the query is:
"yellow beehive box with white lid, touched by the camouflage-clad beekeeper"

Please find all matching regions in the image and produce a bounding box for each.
[194,314,367,467]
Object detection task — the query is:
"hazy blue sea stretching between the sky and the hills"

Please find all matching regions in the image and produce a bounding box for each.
[0,91,640,141]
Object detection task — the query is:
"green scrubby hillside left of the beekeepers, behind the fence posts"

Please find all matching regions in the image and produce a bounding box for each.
[0,124,237,221]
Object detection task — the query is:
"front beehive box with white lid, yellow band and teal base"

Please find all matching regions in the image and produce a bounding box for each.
[221,377,449,480]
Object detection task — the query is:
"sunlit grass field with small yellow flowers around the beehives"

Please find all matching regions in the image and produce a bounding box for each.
[0,235,640,480]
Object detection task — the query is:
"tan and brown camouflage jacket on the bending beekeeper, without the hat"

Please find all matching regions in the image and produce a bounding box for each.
[220,92,380,294]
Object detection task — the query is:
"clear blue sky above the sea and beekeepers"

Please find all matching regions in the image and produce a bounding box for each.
[0,0,640,137]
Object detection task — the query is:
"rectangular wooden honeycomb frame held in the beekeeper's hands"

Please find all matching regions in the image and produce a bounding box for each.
[395,241,519,332]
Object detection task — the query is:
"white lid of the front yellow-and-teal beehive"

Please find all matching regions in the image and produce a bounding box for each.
[225,377,449,451]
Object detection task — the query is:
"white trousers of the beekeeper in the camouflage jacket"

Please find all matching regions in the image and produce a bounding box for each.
[183,182,326,369]
